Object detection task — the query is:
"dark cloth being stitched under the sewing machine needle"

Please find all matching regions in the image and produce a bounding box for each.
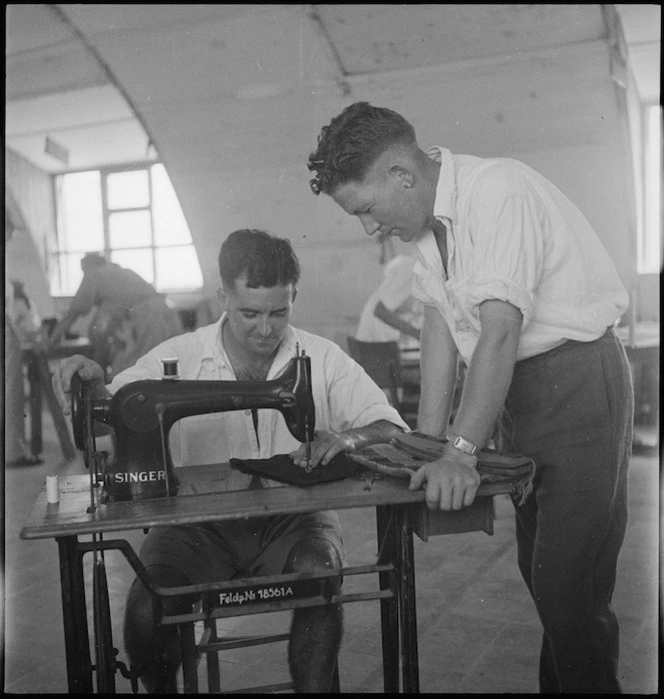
[230,453,361,486]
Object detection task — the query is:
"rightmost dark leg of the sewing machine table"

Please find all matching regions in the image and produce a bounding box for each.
[394,505,420,694]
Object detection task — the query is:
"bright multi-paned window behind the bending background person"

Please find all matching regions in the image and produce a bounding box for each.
[51,163,203,296]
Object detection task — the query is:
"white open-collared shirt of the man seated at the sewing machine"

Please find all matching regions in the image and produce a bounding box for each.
[107,315,408,490]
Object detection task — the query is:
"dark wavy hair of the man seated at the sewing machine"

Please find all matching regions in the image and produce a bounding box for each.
[219,228,300,289]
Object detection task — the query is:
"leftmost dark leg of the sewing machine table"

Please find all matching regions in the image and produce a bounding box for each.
[56,536,93,694]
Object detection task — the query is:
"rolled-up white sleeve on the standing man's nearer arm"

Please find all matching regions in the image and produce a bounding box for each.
[466,171,544,326]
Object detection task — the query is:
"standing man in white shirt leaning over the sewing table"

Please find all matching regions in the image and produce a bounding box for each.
[308,102,633,693]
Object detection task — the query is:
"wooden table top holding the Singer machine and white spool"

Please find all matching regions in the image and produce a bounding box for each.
[21,464,425,539]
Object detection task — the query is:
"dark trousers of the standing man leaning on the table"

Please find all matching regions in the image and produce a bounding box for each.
[501,330,634,693]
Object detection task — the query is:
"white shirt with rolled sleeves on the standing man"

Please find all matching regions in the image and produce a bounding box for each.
[413,146,629,364]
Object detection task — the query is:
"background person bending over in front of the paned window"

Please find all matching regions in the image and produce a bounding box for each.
[51,253,182,378]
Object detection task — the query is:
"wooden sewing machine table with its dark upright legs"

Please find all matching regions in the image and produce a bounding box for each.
[21,464,493,693]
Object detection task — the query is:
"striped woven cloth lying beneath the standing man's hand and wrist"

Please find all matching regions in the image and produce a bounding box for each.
[349,432,535,502]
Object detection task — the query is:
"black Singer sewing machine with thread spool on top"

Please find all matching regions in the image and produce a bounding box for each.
[71,347,315,503]
